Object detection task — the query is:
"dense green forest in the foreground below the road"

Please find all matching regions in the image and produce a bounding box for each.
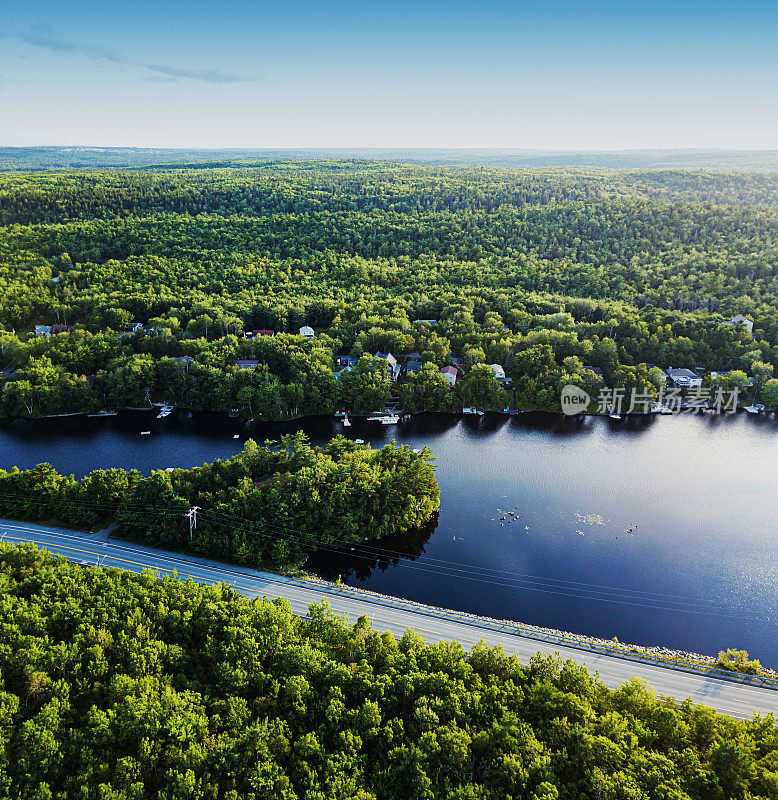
[0,544,778,800]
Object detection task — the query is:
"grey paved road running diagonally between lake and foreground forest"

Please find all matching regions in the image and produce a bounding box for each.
[0,520,778,718]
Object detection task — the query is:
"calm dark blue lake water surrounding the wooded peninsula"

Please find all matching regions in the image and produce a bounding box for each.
[0,414,778,666]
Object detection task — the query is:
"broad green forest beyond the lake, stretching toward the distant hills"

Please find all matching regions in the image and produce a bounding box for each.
[0,166,778,419]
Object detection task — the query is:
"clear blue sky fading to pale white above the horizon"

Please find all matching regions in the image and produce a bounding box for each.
[0,0,778,150]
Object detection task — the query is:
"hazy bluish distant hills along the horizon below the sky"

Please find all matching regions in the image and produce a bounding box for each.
[0,147,778,172]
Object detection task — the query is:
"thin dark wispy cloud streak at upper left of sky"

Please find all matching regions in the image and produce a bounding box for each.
[5,24,256,84]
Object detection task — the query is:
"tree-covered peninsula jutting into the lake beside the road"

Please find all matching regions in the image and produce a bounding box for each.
[0,433,440,568]
